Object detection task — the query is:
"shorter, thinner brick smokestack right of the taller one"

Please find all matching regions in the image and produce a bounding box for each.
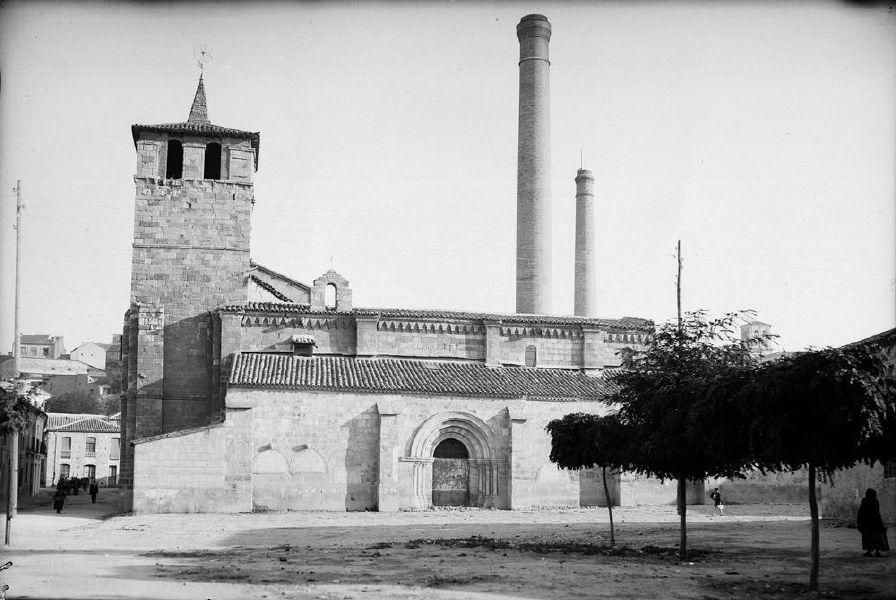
[573,169,597,317]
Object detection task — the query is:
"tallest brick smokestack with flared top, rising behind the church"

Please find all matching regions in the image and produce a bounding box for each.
[516,15,551,314]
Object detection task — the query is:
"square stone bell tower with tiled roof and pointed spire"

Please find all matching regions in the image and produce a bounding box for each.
[122,76,259,474]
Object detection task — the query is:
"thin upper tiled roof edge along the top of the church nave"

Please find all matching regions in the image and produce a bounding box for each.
[218,302,653,333]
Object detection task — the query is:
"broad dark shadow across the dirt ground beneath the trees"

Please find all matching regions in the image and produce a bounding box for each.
[108,522,894,600]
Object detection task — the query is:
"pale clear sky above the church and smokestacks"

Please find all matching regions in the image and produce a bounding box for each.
[0,1,896,352]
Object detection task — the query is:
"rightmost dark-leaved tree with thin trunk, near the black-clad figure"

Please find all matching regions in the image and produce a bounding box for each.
[737,345,896,591]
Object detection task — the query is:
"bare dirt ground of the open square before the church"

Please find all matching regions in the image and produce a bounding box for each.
[0,490,896,600]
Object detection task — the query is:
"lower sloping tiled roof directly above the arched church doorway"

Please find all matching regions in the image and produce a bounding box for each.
[230,353,611,401]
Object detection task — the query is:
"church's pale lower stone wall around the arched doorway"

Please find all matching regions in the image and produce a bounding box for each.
[126,389,702,512]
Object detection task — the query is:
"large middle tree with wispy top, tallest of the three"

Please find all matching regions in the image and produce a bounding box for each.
[609,311,758,560]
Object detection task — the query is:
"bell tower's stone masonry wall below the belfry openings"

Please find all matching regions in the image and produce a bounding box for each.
[131,177,254,435]
